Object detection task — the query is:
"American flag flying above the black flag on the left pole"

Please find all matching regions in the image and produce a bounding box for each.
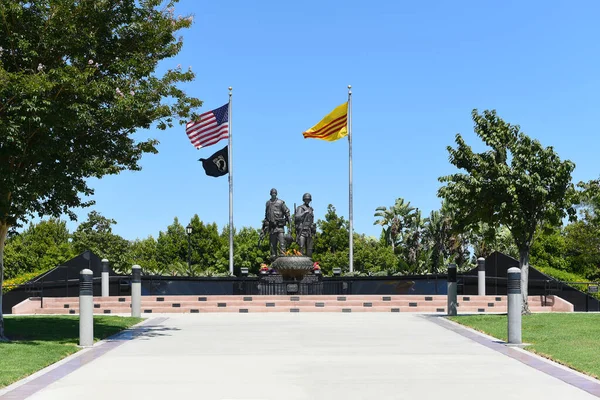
[185,104,229,149]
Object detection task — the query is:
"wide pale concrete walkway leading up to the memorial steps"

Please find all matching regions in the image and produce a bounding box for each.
[0,313,600,400]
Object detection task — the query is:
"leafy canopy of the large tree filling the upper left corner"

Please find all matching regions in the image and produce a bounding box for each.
[0,0,201,338]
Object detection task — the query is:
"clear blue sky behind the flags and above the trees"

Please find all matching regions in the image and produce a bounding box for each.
[63,0,600,239]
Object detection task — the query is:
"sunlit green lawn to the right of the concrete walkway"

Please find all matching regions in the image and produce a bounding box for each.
[450,313,600,378]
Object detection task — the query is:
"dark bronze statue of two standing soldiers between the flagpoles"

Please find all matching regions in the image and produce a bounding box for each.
[261,189,316,259]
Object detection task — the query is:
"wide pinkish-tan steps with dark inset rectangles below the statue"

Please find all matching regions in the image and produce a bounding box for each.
[13,295,572,314]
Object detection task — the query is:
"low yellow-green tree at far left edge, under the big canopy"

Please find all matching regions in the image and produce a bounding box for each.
[4,218,74,278]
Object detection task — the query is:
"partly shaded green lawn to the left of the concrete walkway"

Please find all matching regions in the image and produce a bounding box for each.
[0,316,142,388]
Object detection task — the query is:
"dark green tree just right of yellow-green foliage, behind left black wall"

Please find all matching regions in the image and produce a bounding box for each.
[72,211,131,273]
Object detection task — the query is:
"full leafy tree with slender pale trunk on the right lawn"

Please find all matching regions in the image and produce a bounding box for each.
[438,110,575,313]
